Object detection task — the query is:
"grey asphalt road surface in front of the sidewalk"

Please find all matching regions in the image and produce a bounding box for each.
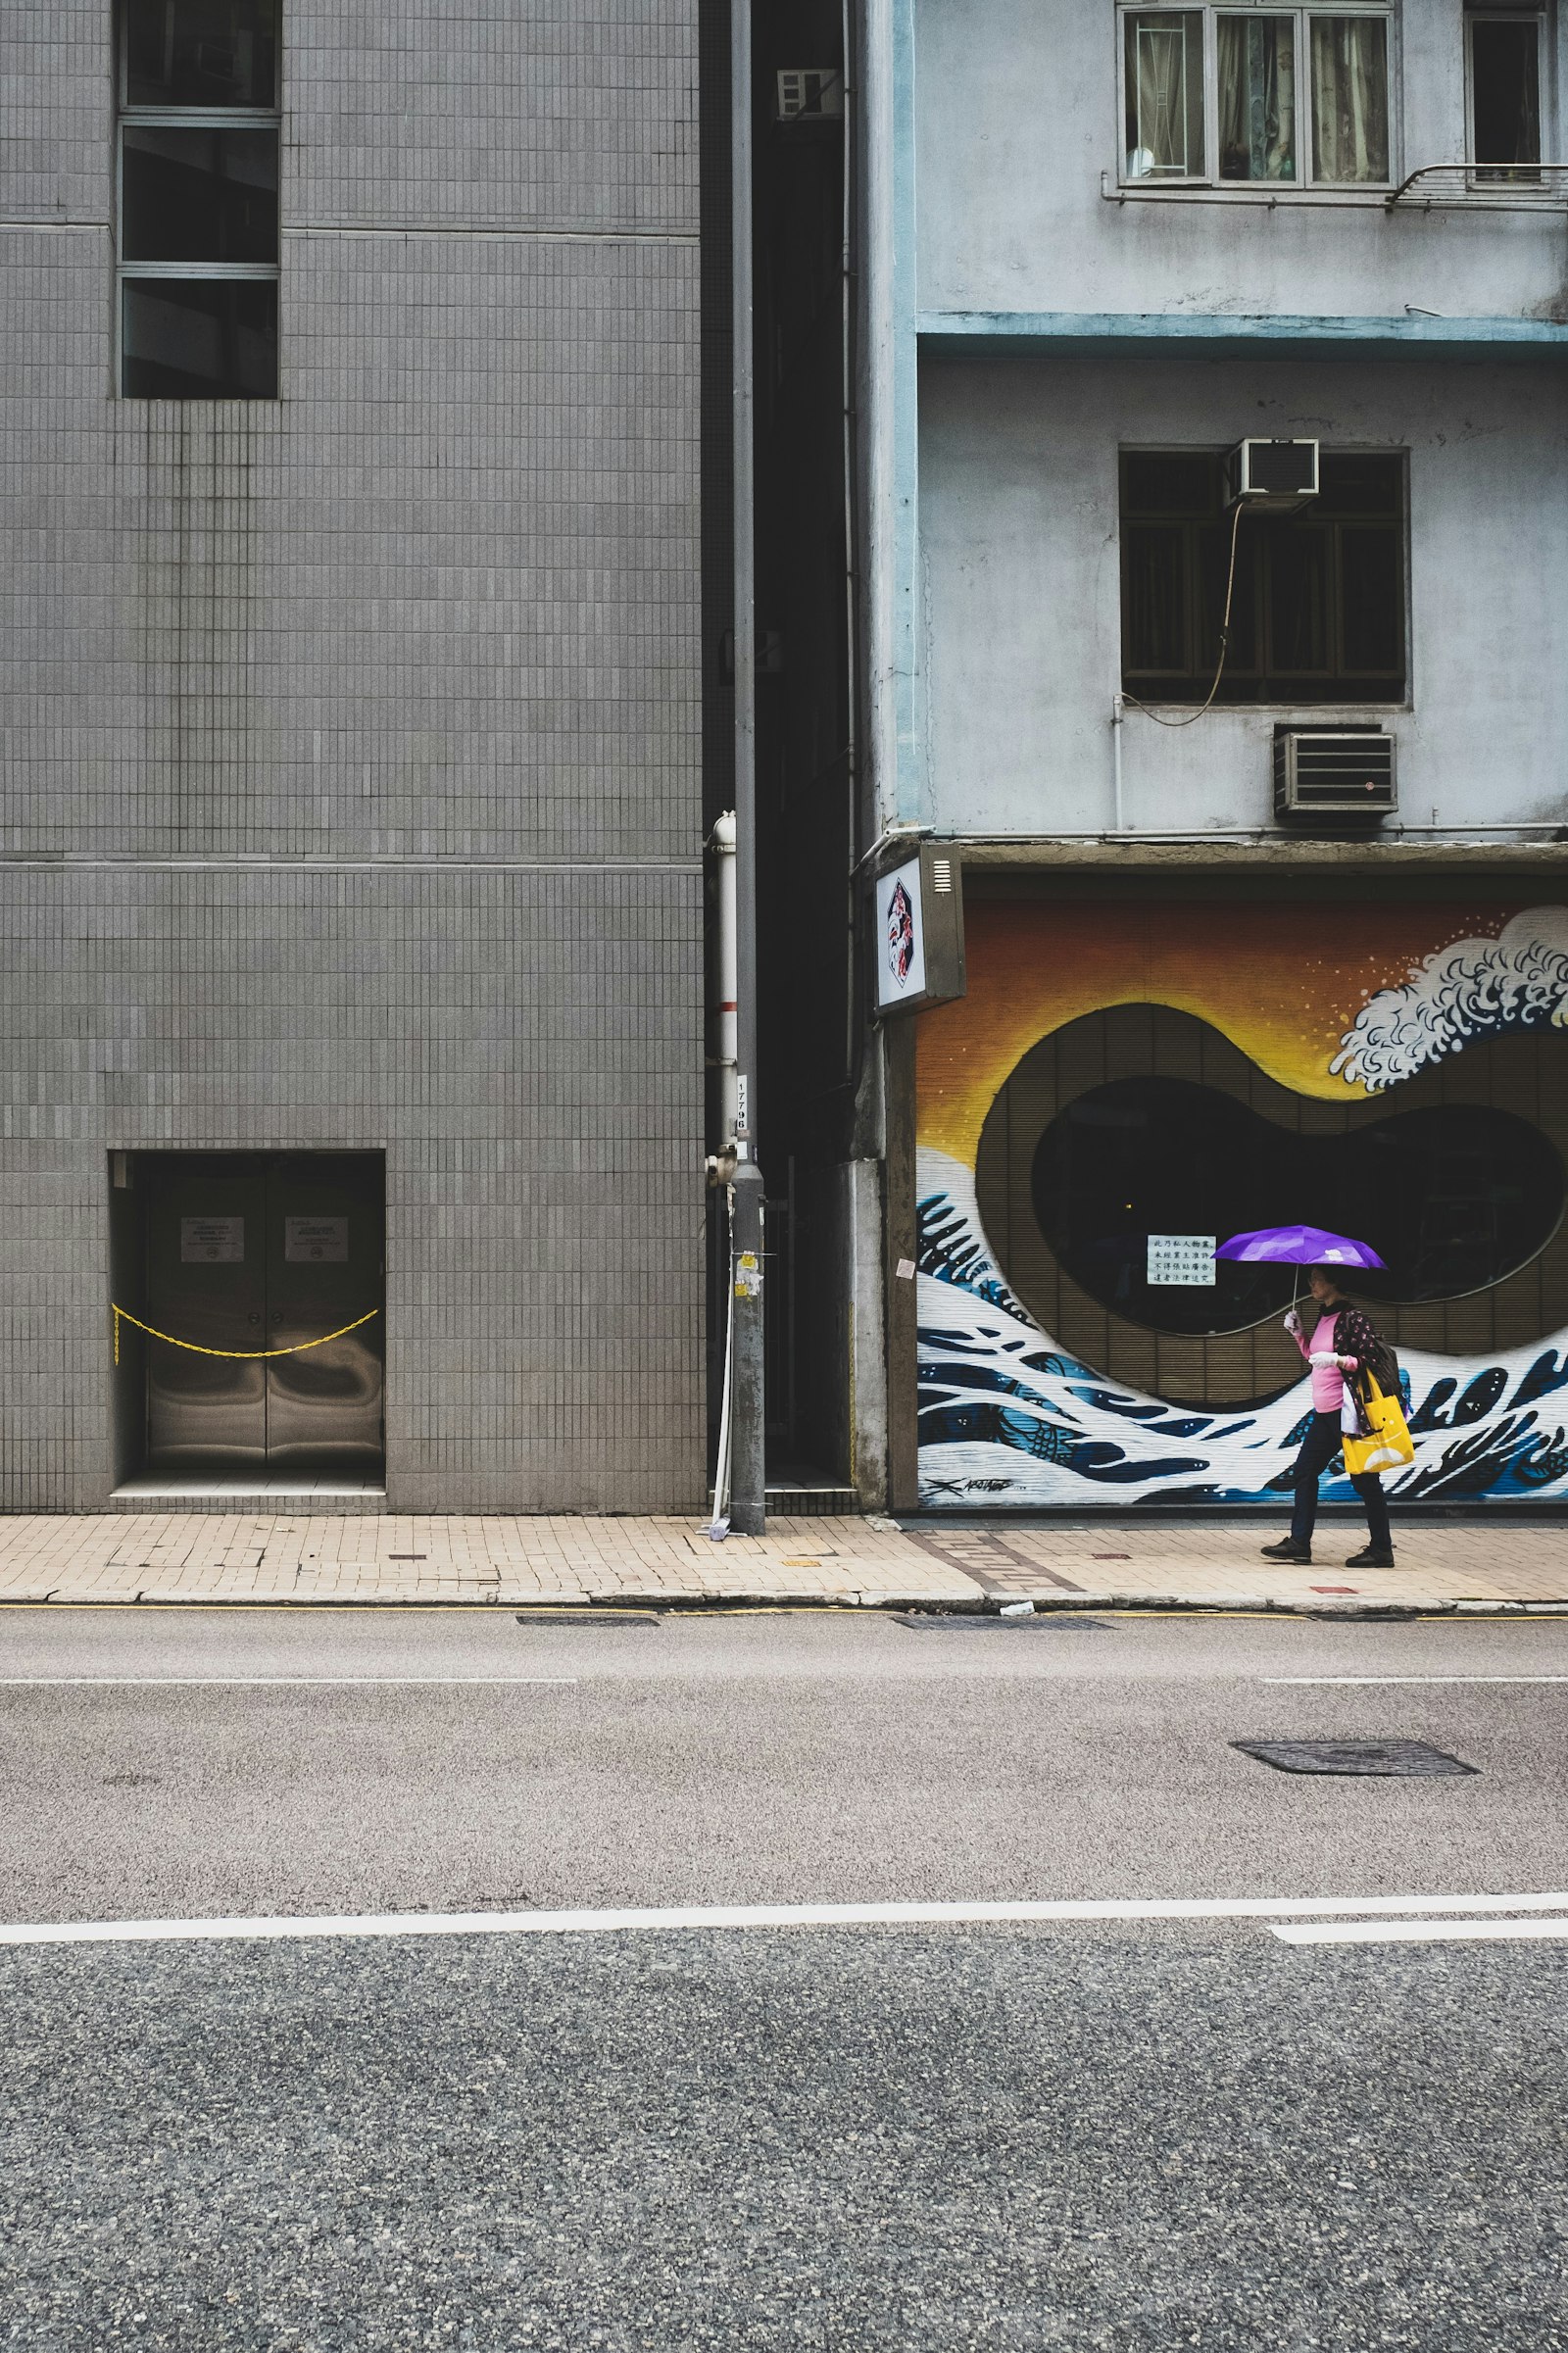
[0,1609,1568,2353]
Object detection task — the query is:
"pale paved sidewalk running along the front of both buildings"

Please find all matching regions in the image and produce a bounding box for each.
[0,1510,1568,1612]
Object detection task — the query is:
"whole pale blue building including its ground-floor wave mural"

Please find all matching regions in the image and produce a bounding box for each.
[861,0,1568,1510]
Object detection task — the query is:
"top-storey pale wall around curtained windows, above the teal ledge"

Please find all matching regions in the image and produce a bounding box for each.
[916,0,1568,318]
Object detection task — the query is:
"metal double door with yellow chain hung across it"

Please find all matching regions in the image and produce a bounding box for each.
[144,1152,386,1473]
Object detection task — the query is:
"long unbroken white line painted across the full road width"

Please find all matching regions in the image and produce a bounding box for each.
[0,1894,1568,1946]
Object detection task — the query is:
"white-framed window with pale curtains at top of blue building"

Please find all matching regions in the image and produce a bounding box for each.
[1121,7,1392,188]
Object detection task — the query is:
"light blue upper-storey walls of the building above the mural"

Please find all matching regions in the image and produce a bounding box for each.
[868,0,1568,835]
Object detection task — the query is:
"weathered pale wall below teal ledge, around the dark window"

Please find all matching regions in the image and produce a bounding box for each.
[920,360,1568,835]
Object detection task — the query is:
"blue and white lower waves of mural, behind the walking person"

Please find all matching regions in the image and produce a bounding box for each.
[918,1146,1568,1510]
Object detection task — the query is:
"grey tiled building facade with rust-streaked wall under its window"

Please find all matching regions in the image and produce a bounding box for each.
[0,0,704,1510]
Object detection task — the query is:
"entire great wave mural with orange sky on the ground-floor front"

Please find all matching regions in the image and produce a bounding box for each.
[916,899,1568,1510]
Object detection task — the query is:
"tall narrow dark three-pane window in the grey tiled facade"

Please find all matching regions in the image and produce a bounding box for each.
[121,0,280,400]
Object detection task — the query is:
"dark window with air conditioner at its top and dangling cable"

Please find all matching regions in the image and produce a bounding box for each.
[1121,450,1405,704]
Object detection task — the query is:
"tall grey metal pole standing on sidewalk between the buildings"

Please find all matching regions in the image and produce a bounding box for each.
[730,0,767,1537]
